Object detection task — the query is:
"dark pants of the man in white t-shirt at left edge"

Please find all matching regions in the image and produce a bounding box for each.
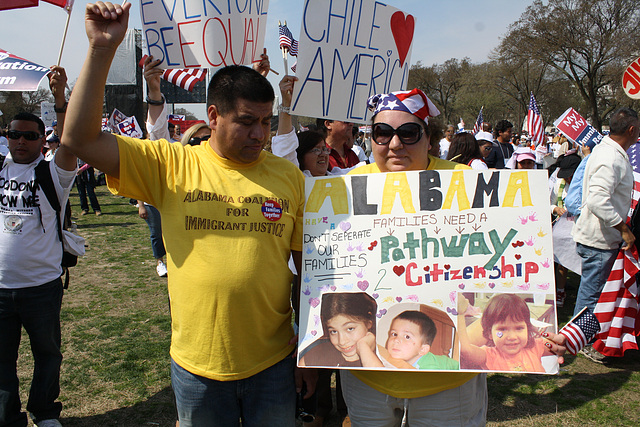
[0,279,63,427]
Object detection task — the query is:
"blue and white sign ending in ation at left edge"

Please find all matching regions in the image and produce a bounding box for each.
[0,49,50,92]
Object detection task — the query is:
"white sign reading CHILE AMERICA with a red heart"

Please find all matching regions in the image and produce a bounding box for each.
[292,0,415,123]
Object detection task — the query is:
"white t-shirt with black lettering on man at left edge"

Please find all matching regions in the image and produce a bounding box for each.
[0,154,76,289]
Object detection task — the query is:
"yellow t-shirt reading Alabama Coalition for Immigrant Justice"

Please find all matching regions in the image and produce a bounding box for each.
[107,137,304,380]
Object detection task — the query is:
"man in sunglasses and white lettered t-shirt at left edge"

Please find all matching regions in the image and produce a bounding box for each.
[0,67,76,427]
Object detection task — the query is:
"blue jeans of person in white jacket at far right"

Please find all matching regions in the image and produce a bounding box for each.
[573,243,619,316]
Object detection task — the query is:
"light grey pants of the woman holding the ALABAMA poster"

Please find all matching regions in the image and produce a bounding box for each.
[340,370,489,427]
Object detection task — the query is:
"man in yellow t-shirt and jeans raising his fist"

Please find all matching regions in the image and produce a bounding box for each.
[62,3,314,427]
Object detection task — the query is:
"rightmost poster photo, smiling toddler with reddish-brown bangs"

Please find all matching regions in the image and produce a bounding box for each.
[458,293,558,373]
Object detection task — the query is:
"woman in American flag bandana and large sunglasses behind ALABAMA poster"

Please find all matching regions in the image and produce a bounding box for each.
[341,89,563,427]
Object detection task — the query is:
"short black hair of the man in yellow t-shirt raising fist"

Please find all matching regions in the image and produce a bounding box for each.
[207,65,275,115]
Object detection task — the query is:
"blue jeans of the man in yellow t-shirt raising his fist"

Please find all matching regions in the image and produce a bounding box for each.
[171,356,296,427]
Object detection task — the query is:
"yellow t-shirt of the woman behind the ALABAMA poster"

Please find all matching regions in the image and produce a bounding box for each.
[349,155,476,399]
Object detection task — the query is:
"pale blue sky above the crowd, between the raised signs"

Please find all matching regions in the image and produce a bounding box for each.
[0,0,532,118]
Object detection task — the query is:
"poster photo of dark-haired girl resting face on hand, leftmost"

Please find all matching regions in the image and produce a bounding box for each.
[299,292,378,367]
